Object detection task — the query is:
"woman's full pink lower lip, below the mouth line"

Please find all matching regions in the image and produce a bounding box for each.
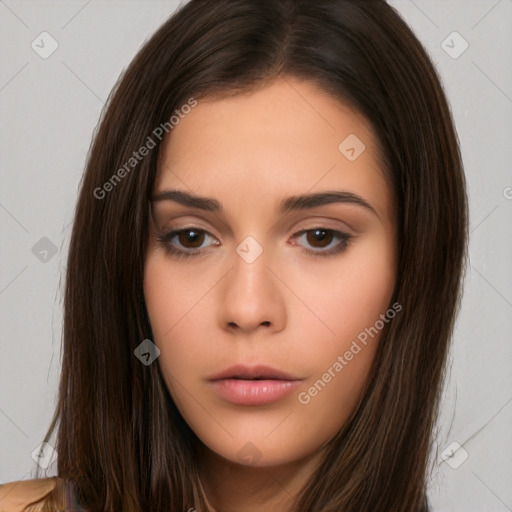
[210,379,301,405]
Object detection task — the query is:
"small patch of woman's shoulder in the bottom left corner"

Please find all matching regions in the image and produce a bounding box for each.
[0,477,57,512]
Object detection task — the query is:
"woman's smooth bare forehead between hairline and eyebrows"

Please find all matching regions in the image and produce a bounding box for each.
[155,78,390,220]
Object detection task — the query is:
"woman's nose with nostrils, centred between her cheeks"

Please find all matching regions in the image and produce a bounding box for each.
[218,244,286,334]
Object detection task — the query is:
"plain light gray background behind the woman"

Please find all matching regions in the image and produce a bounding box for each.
[0,0,512,512]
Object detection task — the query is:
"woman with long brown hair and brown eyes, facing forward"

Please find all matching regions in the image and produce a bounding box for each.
[0,0,467,512]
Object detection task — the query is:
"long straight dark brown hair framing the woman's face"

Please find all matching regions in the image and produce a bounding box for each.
[27,0,468,512]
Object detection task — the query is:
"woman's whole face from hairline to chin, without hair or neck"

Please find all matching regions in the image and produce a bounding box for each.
[144,78,396,466]
